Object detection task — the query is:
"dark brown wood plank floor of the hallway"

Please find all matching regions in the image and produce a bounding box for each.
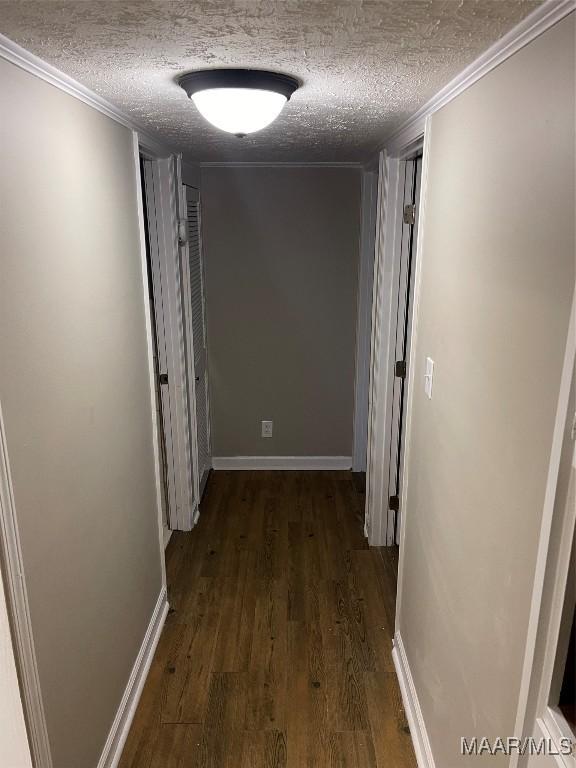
[119,472,416,768]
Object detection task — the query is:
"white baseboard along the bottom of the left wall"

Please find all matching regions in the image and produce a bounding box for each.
[98,587,168,768]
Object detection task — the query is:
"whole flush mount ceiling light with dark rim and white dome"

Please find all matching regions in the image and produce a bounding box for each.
[178,69,299,136]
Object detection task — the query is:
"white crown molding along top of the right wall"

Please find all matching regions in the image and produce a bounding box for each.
[382,0,576,155]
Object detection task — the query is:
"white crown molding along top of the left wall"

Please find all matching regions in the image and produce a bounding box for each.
[0,34,175,157]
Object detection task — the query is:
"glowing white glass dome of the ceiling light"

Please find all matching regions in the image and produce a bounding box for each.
[191,88,287,135]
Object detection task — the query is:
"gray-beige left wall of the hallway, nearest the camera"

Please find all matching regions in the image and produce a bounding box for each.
[0,61,161,768]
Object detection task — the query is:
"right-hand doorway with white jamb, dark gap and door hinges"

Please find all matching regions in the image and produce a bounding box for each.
[364,148,423,547]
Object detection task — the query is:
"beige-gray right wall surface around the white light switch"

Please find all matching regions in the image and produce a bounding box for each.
[399,16,575,768]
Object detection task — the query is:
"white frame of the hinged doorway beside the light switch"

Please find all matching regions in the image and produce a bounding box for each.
[364,126,429,546]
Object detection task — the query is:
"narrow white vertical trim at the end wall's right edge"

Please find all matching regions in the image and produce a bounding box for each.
[352,170,378,472]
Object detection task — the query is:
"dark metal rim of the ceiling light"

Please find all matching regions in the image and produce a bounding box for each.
[178,69,300,101]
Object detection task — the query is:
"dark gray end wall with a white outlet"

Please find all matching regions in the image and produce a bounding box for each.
[202,168,360,456]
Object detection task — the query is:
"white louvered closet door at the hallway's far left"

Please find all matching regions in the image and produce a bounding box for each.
[186,187,211,493]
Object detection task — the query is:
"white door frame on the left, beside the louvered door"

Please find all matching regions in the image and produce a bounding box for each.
[140,147,198,531]
